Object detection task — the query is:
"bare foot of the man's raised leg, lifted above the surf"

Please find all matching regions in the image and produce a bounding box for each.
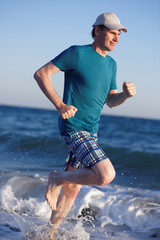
[45,171,62,210]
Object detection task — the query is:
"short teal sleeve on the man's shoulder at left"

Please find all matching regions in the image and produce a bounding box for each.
[51,46,78,72]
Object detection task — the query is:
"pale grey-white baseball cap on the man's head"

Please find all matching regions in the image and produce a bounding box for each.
[93,13,127,32]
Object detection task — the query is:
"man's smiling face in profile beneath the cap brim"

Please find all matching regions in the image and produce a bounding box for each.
[96,28,121,51]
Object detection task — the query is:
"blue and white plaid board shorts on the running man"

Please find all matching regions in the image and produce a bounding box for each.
[62,131,108,170]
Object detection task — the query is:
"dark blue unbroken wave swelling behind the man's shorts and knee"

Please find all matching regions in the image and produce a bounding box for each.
[0,132,160,180]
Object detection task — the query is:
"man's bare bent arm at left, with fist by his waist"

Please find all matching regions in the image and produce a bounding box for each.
[34,62,77,119]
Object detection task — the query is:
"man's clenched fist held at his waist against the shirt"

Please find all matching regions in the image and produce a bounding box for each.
[57,104,78,119]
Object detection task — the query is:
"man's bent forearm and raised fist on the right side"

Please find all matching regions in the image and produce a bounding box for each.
[106,82,136,108]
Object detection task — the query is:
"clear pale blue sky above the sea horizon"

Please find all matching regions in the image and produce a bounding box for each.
[0,0,160,119]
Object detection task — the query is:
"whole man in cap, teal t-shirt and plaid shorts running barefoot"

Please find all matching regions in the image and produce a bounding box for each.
[34,13,136,236]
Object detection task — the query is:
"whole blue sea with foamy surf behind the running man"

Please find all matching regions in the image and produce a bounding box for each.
[0,105,160,240]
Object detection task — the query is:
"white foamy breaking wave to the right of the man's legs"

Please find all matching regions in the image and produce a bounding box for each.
[74,186,160,232]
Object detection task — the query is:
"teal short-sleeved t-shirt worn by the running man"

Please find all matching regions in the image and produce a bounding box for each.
[52,45,117,134]
